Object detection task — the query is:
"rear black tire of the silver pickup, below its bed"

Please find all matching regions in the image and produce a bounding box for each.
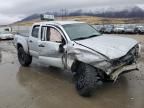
[18,47,32,67]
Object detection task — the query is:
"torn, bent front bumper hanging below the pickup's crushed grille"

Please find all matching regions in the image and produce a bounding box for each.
[110,64,139,80]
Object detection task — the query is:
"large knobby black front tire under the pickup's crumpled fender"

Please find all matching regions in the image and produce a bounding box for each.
[74,63,102,97]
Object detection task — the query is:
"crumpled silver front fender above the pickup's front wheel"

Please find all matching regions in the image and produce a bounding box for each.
[67,45,105,68]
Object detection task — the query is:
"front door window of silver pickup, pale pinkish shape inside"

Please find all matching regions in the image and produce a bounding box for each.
[41,26,62,43]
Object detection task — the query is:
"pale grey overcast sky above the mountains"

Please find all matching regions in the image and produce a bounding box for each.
[0,0,144,25]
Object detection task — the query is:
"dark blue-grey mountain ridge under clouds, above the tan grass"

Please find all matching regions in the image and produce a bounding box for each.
[20,6,144,22]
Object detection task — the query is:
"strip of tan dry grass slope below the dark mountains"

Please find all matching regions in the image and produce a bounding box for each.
[14,16,144,26]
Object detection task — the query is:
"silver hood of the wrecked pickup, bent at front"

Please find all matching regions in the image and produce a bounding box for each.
[76,35,138,59]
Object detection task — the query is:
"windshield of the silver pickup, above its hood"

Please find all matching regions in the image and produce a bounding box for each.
[63,23,101,40]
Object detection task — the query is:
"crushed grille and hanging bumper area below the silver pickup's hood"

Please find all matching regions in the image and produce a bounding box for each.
[94,44,140,80]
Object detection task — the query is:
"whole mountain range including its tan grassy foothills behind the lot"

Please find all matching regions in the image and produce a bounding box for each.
[14,6,144,25]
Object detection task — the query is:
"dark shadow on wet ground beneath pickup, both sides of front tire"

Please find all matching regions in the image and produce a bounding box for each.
[17,65,128,97]
